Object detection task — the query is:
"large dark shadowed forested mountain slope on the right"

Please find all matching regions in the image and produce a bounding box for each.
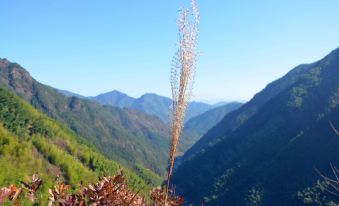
[172,48,339,206]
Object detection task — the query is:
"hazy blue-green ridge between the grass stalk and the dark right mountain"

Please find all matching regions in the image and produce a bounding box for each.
[180,102,242,151]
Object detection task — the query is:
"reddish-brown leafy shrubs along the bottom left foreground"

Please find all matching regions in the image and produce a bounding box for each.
[0,171,184,206]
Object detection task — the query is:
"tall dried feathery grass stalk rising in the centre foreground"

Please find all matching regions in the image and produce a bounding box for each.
[166,0,199,198]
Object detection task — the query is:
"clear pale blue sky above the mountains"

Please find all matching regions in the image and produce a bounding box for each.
[0,0,339,101]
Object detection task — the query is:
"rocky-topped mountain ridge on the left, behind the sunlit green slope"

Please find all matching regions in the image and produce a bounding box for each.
[0,59,168,174]
